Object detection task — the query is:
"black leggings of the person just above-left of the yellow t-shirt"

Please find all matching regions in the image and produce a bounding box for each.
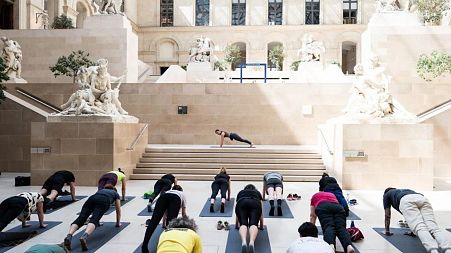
[141,193,181,253]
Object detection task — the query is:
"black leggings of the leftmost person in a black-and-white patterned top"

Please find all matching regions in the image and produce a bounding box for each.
[0,196,28,232]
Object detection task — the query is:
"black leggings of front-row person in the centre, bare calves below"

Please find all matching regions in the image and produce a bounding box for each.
[235,198,262,227]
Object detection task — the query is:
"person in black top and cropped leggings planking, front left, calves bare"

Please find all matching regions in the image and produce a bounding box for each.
[64,184,121,251]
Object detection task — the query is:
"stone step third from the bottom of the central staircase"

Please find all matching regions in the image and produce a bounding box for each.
[136,163,325,170]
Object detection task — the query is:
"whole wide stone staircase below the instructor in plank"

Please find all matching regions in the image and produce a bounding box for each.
[130,145,325,182]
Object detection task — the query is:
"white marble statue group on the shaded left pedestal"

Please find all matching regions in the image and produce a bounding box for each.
[60,59,128,116]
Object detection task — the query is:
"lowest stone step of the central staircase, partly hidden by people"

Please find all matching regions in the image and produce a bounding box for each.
[130,174,321,182]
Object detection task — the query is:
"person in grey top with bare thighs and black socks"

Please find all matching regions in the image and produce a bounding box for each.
[263,172,283,216]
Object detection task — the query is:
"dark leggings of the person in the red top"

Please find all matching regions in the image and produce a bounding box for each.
[315,202,351,251]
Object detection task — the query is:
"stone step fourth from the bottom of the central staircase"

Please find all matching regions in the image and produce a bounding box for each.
[140,157,323,164]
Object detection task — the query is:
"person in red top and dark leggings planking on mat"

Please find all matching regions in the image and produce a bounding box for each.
[310,192,355,253]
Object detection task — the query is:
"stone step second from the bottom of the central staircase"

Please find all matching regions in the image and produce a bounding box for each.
[133,168,325,176]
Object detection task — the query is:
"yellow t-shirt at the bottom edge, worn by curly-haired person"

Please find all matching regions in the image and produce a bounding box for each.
[157,228,202,253]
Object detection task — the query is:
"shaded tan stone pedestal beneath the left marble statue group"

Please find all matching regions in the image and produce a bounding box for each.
[30,120,148,186]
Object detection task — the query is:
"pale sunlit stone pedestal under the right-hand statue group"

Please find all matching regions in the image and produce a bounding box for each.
[319,124,434,191]
